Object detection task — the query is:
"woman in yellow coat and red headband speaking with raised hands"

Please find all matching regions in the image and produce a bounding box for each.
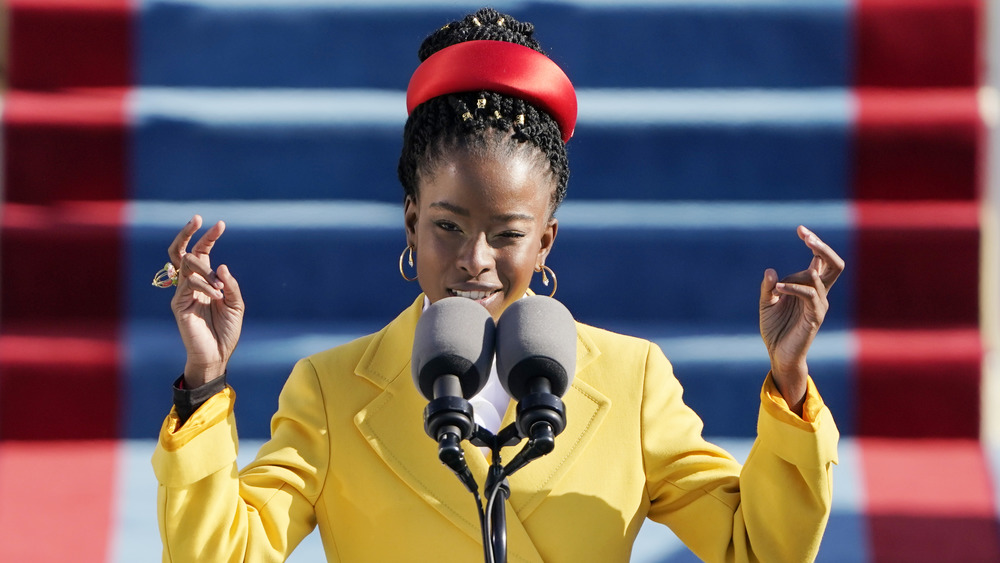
[153,9,843,561]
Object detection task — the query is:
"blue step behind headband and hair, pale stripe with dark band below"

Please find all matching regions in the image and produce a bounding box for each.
[131,90,853,202]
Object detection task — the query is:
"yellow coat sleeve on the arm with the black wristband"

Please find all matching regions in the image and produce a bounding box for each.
[153,360,330,562]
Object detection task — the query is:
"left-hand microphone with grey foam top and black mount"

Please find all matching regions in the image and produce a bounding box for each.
[410,297,496,492]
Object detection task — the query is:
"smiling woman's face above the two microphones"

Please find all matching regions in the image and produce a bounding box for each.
[405,150,558,319]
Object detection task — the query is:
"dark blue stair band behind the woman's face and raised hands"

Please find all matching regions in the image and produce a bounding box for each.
[127,225,853,326]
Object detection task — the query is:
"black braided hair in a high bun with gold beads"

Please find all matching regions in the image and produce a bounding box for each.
[397,8,569,213]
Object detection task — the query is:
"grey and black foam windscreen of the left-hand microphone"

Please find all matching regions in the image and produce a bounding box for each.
[410,297,496,400]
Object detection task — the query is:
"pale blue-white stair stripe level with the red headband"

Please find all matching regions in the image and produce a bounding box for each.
[129,88,855,129]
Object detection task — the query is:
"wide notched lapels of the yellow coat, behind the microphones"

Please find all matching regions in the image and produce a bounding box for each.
[354,294,611,561]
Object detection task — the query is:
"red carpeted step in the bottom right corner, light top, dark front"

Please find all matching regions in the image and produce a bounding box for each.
[860,442,1000,563]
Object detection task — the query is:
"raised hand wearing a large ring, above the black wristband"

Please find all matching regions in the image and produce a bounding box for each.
[167,215,244,388]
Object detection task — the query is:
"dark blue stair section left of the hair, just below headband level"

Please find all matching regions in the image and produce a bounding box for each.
[132,119,403,202]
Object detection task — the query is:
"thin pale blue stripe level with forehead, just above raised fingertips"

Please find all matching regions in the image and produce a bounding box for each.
[125,200,851,230]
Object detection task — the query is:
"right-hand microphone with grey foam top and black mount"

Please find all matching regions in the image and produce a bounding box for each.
[496,295,577,474]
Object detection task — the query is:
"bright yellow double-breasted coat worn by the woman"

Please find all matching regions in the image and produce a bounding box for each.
[153,296,839,563]
